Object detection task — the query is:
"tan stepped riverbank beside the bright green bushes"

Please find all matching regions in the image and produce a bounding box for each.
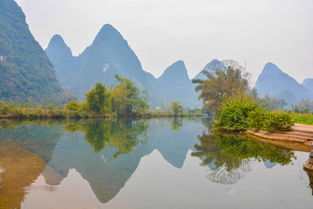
[245,123,313,146]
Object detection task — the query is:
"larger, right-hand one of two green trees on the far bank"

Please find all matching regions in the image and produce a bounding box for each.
[111,75,149,116]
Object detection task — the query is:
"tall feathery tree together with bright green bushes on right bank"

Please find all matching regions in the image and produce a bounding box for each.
[193,60,293,132]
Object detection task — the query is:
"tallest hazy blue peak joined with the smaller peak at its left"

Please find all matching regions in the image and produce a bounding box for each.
[46,24,154,98]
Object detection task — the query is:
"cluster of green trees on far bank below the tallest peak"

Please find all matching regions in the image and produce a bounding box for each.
[64,75,149,117]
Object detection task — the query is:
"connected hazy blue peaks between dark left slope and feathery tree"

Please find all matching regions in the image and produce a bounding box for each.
[46,24,199,106]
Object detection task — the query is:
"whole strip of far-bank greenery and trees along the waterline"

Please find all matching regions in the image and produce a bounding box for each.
[0,75,204,119]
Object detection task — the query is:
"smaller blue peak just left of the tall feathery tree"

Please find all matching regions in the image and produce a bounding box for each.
[156,61,199,106]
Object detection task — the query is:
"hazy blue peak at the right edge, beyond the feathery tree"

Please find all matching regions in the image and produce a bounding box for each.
[255,63,313,104]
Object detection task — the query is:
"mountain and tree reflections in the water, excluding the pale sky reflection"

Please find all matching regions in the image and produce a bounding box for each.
[0,119,312,209]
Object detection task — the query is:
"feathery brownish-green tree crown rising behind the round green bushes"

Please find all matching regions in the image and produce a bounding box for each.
[193,60,250,114]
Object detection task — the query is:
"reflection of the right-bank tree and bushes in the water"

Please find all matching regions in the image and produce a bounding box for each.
[192,133,295,184]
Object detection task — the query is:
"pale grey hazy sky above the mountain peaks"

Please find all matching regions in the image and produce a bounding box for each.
[17,0,313,82]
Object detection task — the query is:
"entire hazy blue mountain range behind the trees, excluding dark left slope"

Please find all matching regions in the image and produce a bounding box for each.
[46,24,313,108]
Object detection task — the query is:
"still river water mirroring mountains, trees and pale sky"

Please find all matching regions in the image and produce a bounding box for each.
[0,119,313,209]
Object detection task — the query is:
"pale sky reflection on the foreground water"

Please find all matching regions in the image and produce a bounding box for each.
[22,150,313,209]
